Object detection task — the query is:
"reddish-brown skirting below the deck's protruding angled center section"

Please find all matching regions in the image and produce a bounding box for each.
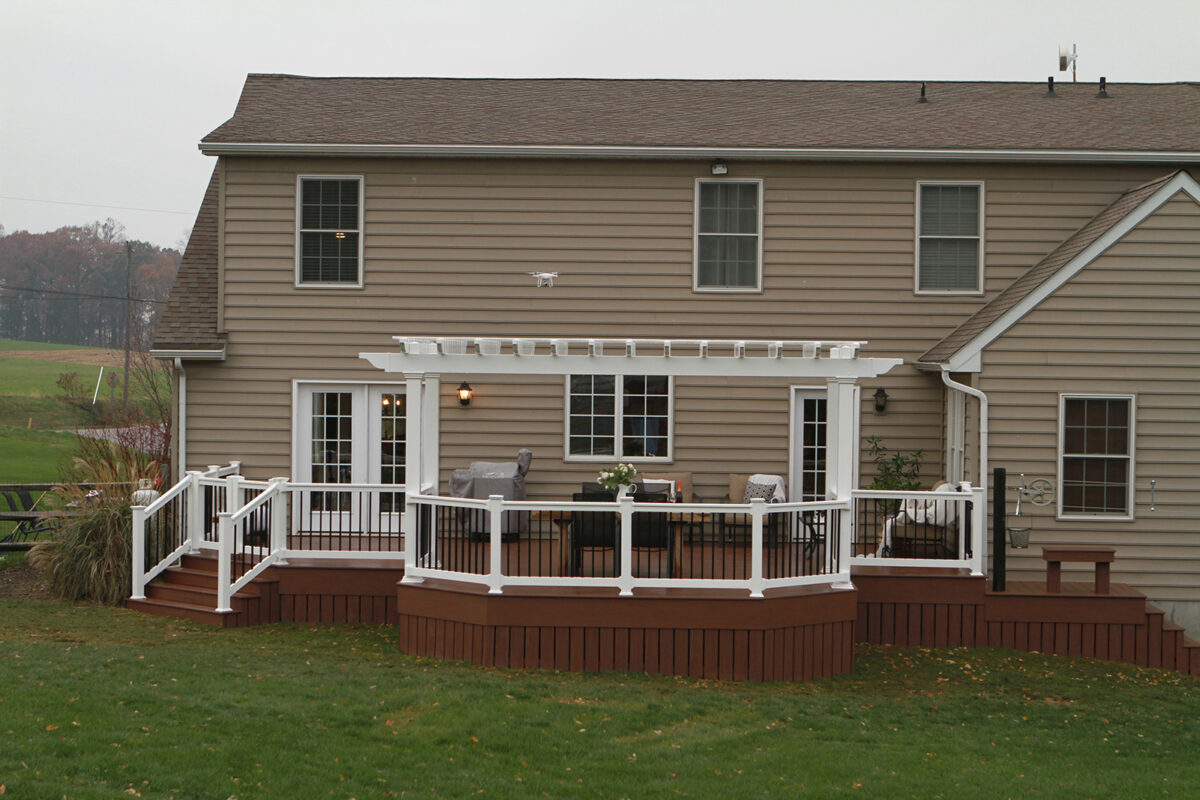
[397,582,857,681]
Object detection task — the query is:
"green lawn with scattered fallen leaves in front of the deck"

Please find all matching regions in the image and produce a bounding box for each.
[0,601,1200,800]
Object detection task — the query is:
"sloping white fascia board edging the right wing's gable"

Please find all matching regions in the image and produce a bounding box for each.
[946,173,1200,372]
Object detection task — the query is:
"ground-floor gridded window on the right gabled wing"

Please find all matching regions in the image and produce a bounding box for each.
[1058,397,1133,517]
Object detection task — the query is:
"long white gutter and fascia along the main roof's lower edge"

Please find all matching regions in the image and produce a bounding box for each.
[198,142,1200,164]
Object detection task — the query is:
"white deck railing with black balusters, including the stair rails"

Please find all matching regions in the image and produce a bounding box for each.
[132,467,986,612]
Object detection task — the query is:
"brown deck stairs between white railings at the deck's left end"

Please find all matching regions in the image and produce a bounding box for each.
[126,554,280,627]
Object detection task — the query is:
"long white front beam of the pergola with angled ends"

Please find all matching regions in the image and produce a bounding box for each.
[359,353,904,379]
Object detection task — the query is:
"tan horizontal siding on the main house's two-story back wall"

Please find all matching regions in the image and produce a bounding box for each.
[188,158,1158,499]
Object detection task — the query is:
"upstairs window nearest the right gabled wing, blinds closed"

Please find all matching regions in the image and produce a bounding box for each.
[916,184,983,294]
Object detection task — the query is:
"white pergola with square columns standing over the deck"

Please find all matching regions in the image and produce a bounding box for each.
[360,336,901,518]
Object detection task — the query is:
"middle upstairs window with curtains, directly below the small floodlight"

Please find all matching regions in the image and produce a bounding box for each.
[692,180,762,291]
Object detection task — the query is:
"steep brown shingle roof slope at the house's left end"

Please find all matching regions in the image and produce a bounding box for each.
[154,163,224,350]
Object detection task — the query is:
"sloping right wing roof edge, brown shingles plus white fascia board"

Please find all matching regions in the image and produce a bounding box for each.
[917,170,1200,372]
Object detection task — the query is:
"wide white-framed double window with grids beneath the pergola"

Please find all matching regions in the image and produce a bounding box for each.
[566,375,671,461]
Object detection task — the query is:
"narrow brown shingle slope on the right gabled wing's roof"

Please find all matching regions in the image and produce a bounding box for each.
[917,170,1183,363]
